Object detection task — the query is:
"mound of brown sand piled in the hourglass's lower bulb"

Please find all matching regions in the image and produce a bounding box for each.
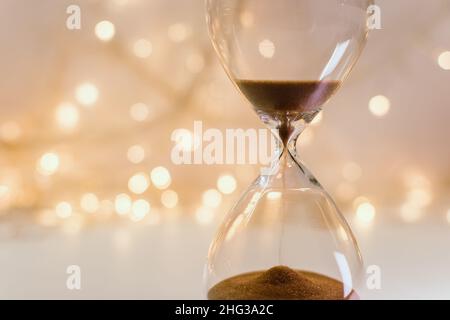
[208,266,348,300]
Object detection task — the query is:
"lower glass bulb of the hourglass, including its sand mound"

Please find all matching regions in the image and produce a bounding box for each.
[205,149,363,300]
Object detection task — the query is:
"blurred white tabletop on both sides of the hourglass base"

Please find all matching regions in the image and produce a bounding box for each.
[0,212,450,299]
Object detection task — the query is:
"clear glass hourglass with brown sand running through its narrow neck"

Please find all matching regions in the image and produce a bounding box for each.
[205,0,372,300]
